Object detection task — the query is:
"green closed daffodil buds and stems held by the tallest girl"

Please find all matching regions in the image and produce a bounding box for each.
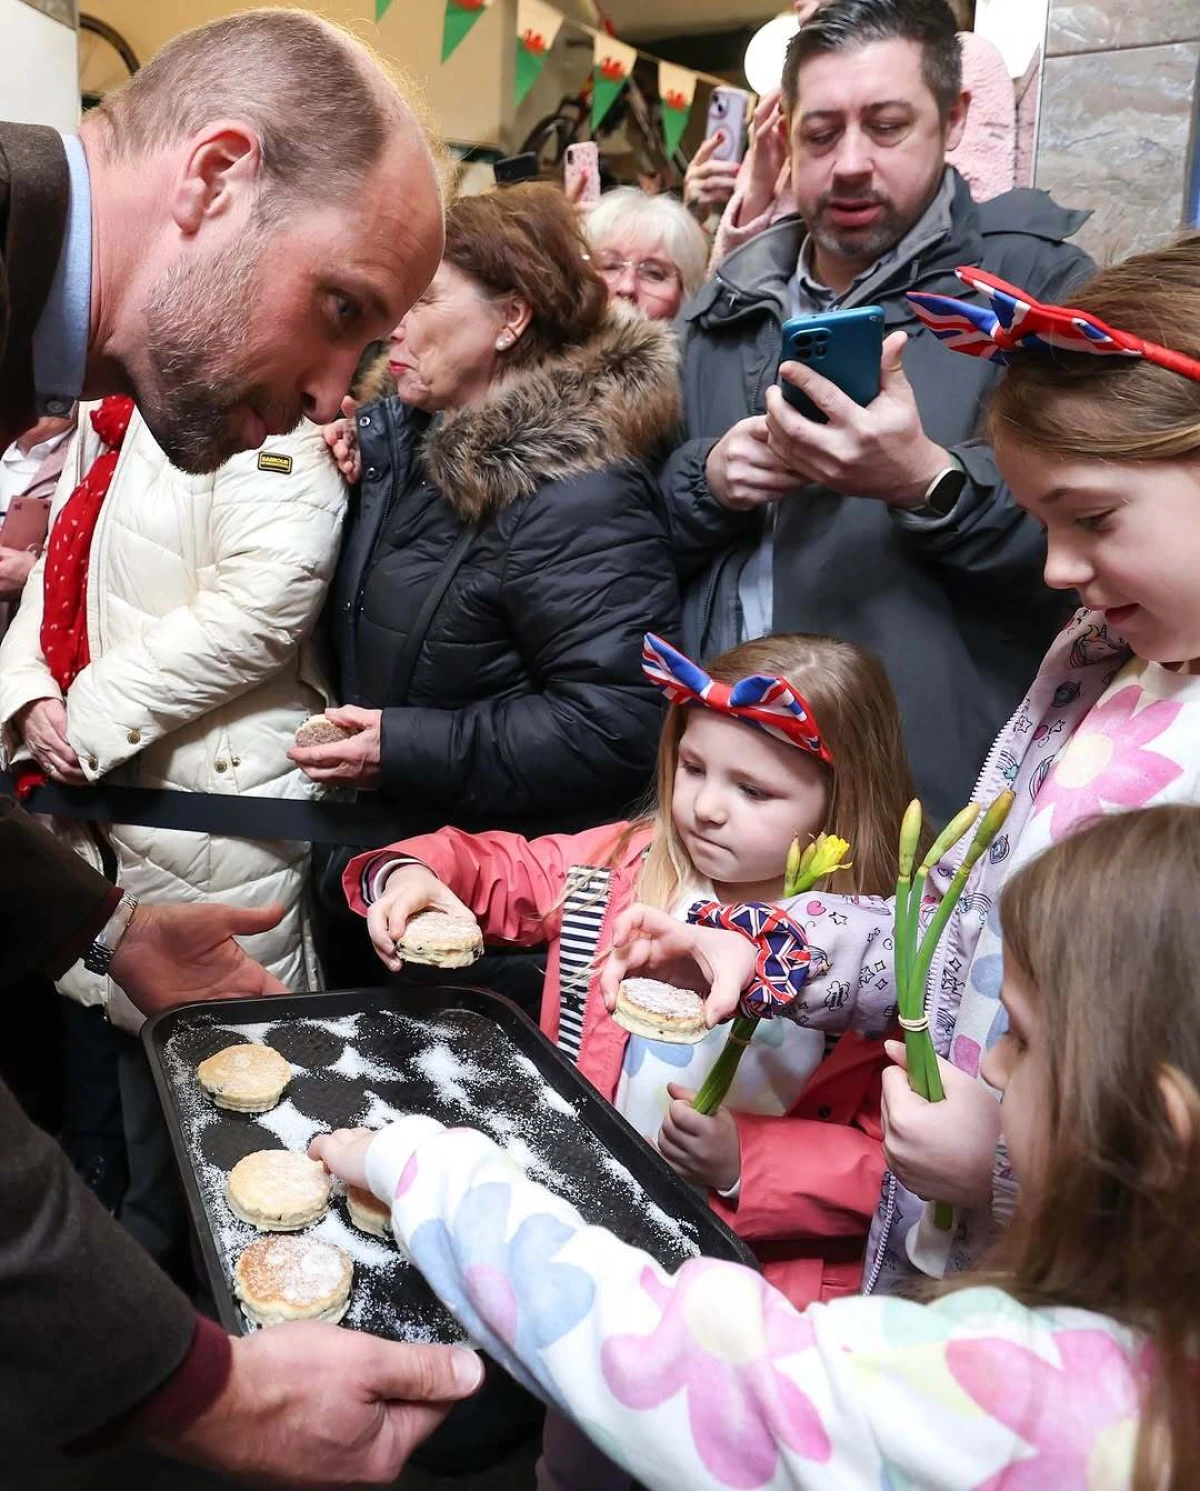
[894,792,1014,1232]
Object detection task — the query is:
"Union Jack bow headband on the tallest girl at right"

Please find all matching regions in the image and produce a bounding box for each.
[908,267,1200,382]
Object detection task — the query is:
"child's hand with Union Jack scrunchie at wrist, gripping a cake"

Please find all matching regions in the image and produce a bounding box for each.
[599,900,756,1029]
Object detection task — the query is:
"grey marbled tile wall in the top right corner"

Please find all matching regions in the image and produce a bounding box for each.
[1036,0,1200,259]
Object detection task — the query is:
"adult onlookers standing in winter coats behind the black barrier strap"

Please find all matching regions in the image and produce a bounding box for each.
[0,3,1088,1258]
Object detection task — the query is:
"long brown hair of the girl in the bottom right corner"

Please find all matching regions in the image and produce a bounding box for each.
[954,807,1200,1491]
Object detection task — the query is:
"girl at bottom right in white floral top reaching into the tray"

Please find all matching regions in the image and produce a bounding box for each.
[310,807,1200,1491]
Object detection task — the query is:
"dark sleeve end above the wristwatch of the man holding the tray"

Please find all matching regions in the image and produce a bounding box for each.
[0,798,121,989]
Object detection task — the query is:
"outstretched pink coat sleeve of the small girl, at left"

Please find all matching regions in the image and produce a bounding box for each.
[341,825,623,947]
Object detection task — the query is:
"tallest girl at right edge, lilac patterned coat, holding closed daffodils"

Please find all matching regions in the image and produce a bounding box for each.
[604,233,1200,1290]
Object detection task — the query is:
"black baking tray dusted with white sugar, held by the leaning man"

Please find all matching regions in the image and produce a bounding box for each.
[142,984,757,1342]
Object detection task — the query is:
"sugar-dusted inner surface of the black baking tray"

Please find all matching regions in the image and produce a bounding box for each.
[161,994,721,1342]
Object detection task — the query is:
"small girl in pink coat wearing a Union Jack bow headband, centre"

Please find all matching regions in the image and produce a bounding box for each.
[343,637,912,1491]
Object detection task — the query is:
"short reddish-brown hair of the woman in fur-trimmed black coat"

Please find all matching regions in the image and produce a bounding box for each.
[444,182,608,367]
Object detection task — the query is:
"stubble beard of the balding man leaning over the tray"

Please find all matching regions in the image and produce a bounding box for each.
[137,228,303,476]
